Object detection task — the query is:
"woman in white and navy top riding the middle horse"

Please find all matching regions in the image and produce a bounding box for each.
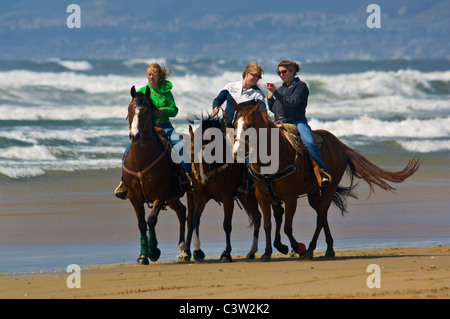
[213,62,266,193]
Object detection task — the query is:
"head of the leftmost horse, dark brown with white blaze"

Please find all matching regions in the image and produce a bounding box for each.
[128,86,155,143]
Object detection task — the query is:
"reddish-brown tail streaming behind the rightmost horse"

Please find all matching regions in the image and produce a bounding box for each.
[341,142,420,195]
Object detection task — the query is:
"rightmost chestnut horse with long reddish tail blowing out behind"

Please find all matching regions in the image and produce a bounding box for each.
[234,105,420,260]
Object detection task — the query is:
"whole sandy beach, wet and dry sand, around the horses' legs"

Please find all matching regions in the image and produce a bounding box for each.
[0,160,450,299]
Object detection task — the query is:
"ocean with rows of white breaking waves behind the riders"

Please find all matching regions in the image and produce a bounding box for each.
[0,59,450,180]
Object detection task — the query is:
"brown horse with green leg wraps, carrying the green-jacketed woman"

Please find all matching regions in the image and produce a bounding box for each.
[122,86,186,265]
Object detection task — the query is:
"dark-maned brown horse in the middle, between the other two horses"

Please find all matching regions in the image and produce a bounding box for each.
[185,116,283,262]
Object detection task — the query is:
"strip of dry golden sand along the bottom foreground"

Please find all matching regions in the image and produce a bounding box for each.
[0,246,450,299]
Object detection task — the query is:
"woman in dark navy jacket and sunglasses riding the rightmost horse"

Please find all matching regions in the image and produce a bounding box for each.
[266,61,331,186]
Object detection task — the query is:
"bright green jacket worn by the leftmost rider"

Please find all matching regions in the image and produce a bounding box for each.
[138,81,178,125]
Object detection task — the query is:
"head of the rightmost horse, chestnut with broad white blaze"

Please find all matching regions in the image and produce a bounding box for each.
[233,102,263,160]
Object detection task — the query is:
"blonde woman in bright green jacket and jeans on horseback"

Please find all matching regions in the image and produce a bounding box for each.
[114,63,191,199]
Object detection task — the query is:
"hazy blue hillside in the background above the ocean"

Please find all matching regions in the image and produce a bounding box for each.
[0,0,450,60]
